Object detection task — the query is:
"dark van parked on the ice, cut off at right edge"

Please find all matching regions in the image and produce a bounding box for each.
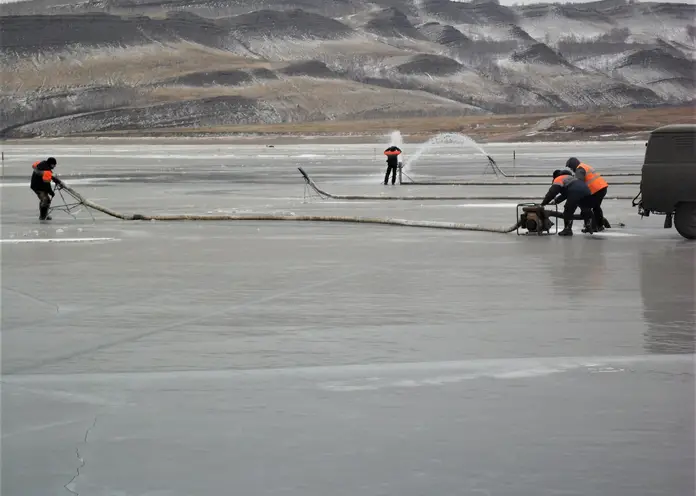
[634,124,696,239]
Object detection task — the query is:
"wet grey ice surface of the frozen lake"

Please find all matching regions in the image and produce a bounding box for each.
[2,136,696,496]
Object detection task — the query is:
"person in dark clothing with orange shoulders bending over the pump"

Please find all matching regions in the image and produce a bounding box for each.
[541,170,592,236]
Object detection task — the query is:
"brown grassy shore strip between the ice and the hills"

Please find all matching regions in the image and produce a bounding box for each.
[2,104,696,145]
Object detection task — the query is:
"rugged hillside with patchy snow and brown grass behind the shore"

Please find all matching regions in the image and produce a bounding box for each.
[0,0,696,135]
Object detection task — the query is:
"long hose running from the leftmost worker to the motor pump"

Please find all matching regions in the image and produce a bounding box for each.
[55,182,519,233]
